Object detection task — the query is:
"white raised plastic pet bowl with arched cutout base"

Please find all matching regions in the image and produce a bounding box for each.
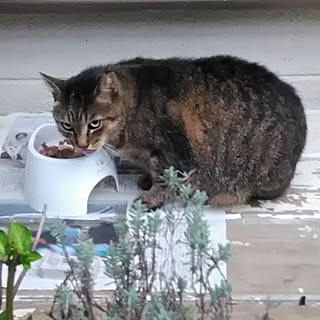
[24,124,119,217]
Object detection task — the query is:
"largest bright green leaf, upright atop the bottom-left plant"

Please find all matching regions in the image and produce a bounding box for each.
[9,223,31,253]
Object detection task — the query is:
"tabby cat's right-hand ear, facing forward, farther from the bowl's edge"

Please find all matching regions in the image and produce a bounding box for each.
[95,72,120,103]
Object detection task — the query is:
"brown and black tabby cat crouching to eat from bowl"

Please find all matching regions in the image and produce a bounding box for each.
[43,56,306,207]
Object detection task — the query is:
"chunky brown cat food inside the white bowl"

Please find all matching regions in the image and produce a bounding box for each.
[39,140,84,159]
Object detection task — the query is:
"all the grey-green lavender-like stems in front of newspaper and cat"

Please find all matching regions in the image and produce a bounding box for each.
[49,167,231,320]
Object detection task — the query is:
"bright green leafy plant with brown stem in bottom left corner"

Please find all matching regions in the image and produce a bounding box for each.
[0,223,41,320]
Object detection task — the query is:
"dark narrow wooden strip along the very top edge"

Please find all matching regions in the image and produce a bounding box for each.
[0,0,320,14]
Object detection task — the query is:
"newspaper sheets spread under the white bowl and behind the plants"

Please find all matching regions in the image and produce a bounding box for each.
[0,113,226,290]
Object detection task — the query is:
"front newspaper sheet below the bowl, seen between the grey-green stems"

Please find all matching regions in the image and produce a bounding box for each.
[3,205,227,292]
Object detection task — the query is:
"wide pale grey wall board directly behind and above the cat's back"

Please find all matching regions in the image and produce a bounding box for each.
[0,9,320,79]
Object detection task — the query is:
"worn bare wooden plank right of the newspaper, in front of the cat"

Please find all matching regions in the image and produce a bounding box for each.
[227,220,320,297]
